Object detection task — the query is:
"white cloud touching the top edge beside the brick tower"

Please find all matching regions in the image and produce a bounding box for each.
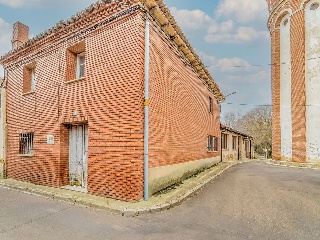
[216,0,268,23]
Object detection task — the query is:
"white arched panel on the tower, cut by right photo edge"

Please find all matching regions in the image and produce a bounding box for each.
[305,1,320,161]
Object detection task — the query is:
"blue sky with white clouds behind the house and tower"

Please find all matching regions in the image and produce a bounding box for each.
[0,0,271,115]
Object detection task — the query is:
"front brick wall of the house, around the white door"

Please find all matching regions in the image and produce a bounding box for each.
[7,14,144,201]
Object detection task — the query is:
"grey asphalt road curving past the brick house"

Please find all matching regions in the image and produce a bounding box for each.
[0,162,320,240]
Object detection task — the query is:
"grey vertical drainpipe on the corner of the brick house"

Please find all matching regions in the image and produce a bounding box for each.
[144,16,150,201]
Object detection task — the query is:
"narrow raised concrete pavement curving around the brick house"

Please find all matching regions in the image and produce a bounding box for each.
[0,162,245,217]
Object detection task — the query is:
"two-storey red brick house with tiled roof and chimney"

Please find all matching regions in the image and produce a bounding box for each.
[0,0,224,201]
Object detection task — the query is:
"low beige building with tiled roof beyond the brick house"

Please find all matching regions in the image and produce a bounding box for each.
[221,124,254,162]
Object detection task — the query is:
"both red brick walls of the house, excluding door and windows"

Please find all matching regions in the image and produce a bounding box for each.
[5,3,220,201]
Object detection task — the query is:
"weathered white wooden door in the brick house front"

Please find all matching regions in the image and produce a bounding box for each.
[69,125,88,188]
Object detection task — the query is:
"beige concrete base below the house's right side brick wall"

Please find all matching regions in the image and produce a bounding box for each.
[149,156,220,196]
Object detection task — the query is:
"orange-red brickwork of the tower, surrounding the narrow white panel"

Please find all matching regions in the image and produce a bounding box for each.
[267,0,320,162]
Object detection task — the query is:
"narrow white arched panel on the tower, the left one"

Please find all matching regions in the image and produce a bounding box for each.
[280,15,292,160]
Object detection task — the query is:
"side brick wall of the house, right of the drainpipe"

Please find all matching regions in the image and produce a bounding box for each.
[149,20,220,167]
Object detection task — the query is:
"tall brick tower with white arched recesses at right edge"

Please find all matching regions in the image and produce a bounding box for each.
[267,0,320,162]
